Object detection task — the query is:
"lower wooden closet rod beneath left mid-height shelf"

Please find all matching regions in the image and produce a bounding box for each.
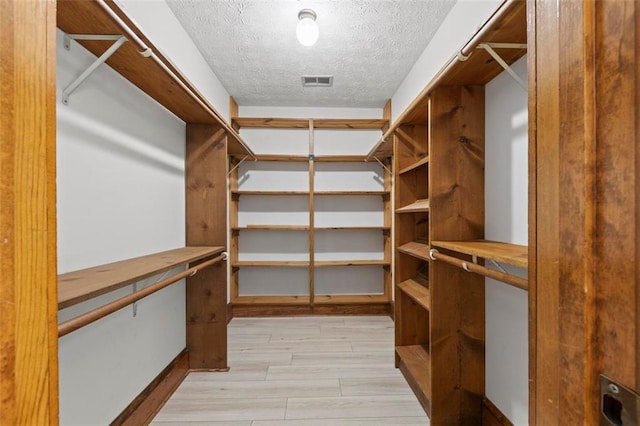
[58,252,228,337]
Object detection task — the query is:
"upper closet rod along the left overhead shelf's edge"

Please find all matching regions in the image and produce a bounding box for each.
[96,0,256,160]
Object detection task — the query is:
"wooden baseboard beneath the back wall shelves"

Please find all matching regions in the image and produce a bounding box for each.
[233,302,391,317]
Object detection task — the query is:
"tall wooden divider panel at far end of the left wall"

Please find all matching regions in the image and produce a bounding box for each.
[185,123,228,370]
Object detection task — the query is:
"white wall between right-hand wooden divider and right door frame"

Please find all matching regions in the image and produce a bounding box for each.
[485,57,529,425]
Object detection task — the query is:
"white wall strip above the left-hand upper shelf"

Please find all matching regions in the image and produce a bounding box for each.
[116,0,229,121]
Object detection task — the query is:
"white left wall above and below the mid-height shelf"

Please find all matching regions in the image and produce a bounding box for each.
[56,32,185,426]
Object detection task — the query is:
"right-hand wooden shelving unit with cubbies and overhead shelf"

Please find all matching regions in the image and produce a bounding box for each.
[378,1,528,425]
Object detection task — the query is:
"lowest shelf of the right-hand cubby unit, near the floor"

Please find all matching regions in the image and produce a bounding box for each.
[396,345,431,416]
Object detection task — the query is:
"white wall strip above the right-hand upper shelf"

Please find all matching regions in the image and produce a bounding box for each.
[391,0,503,121]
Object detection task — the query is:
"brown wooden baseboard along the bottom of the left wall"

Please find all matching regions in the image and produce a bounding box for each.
[111,348,189,426]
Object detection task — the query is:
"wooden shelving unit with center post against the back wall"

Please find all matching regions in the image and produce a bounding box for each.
[230,118,391,315]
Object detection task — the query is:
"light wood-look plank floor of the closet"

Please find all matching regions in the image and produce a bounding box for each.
[153,316,429,426]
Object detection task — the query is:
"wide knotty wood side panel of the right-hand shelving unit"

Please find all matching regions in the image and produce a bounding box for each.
[429,86,485,425]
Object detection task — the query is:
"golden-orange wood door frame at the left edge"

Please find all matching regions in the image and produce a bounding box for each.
[0,0,58,425]
